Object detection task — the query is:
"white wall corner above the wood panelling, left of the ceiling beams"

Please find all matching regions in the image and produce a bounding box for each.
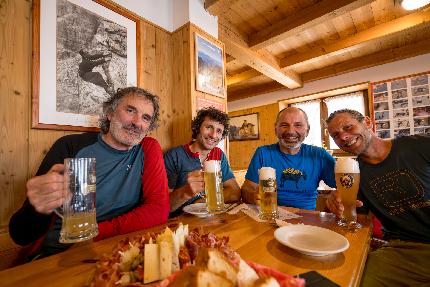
[114,0,218,39]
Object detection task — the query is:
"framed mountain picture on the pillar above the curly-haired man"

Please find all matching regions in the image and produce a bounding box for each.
[194,33,226,98]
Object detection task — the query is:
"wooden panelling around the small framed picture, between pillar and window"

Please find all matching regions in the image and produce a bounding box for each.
[229,103,279,170]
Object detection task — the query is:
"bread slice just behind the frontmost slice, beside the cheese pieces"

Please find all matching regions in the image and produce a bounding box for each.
[195,248,238,285]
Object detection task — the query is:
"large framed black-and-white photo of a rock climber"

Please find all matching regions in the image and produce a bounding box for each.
[32,0,140,131]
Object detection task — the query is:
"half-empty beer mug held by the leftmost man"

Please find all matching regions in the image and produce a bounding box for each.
[56,158,98,243]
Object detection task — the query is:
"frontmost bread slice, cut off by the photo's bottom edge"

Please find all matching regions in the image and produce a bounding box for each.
[168,266,234,287]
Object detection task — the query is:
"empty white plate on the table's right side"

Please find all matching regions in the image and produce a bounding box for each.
[275,224,349,256]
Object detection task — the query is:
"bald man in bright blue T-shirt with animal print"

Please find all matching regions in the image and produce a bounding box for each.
[242,107,336,210]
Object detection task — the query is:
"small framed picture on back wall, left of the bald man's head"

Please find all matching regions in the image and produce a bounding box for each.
[229,113,260,142]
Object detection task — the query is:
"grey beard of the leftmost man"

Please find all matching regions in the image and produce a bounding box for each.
[109,120,146,147]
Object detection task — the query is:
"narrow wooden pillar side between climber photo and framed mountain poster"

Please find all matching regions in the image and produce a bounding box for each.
[171,23,192,146]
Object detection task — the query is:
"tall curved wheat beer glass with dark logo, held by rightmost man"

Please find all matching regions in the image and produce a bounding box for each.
[335,157,361,229]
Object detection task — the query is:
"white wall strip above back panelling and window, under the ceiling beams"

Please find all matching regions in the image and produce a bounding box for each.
[228,54,430,112]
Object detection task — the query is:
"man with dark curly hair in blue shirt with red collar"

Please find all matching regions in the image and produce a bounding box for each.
[164,107,240,217]
